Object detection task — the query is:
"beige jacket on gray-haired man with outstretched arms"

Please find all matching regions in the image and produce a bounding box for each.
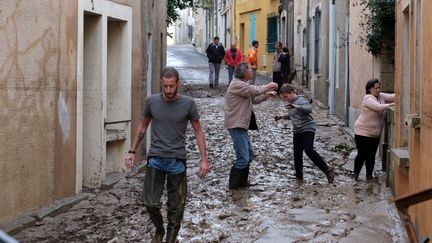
[224,78,271,129]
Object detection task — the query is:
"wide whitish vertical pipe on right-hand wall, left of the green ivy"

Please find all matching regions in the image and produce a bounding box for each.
[328,0,337,114]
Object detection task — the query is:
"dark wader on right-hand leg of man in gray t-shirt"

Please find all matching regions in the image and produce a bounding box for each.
[166,172,187,243]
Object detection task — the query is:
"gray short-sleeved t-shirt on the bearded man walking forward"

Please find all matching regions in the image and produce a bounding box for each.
[143,94,200,159]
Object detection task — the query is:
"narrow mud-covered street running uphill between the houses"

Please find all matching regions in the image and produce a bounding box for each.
[14,44,407,243]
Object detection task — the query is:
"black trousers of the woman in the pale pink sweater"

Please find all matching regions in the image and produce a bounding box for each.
[354,135,380,179]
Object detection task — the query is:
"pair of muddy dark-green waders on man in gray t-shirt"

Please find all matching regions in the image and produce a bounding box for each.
[142,159,187,242]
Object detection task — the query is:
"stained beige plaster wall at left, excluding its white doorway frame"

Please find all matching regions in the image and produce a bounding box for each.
[0,0,166,225]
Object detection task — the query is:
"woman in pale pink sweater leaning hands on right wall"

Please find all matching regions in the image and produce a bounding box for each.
[354,79,395,181]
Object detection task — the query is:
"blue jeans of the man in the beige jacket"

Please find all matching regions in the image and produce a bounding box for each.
[228,128,254,169]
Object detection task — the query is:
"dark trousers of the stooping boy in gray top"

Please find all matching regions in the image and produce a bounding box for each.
[293,132,328,179]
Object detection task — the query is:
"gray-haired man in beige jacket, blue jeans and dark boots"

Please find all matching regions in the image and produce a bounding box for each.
[224,62,278,189]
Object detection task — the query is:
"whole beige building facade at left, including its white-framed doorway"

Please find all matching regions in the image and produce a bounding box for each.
[0,0,166,222]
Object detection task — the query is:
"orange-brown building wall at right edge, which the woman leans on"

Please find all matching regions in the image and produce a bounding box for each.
[393,0,432,239]
